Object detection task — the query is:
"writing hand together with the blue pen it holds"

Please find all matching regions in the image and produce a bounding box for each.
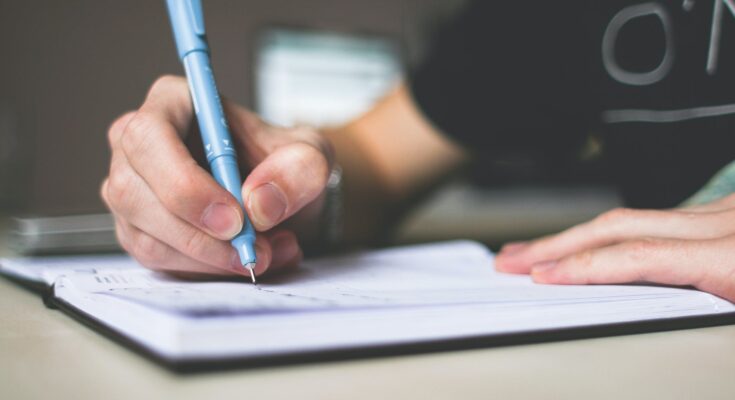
[102,0,333,283]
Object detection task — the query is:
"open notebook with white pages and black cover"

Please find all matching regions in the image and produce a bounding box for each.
[1,241,735,369]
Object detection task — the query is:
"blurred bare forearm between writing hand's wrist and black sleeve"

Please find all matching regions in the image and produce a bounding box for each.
[325,86,466,245]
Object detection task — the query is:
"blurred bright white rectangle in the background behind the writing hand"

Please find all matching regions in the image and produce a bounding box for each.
[255,29,401,126]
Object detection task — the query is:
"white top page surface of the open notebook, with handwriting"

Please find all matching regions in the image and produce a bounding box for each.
[61,244,720,317]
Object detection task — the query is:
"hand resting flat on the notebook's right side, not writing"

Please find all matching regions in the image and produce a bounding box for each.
[495,195,735,301]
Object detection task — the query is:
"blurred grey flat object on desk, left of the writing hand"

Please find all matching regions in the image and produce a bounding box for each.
[9,214,121,255]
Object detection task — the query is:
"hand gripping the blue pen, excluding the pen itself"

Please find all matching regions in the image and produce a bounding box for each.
[101,76,333,275]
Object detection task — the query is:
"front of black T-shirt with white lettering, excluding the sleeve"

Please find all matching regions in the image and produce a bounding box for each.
[585,0,735,207]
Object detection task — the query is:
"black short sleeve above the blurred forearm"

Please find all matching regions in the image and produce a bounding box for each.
[409,0,596,181]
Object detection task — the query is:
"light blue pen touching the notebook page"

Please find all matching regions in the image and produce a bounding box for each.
[166,0,256,283]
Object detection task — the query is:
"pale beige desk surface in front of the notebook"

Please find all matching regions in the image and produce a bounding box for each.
[0,279,735,400]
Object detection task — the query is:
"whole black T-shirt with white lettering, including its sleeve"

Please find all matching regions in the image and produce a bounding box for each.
[411,0,735,207]
